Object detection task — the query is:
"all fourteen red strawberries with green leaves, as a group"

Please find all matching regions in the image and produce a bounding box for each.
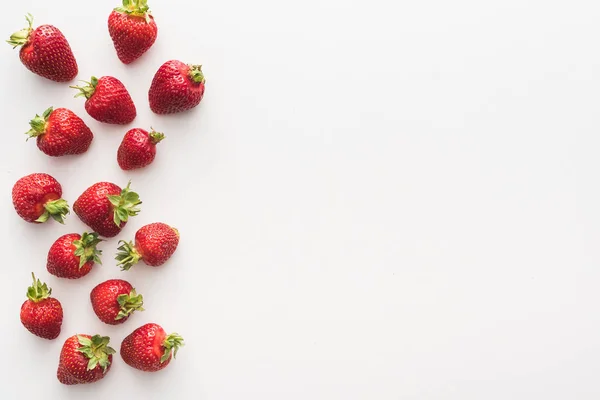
[8,0,204,385]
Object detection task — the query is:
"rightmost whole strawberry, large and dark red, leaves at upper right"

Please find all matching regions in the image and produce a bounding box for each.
[148,60,204,114]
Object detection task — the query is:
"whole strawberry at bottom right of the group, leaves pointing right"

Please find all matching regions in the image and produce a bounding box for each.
[121,324,183,371]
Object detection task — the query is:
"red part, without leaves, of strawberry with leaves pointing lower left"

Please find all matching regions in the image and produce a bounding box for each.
[135,222,179,267]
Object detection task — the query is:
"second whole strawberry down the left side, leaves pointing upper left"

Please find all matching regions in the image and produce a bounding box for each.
[27,107,94,157]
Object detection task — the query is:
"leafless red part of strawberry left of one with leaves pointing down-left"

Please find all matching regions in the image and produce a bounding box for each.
[46,233,94,279]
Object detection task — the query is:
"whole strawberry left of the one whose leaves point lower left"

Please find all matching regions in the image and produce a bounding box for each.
[46,232,102,279]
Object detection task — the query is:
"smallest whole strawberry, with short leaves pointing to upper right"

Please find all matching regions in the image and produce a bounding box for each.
[117,128,165,170]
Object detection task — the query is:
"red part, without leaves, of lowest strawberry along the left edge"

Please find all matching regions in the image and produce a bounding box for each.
[21,297,63,339]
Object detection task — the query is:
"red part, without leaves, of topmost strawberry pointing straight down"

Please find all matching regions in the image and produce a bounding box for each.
[108,11,158,64]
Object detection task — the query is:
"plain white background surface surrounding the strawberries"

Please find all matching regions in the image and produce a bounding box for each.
[0,0,600,400]
